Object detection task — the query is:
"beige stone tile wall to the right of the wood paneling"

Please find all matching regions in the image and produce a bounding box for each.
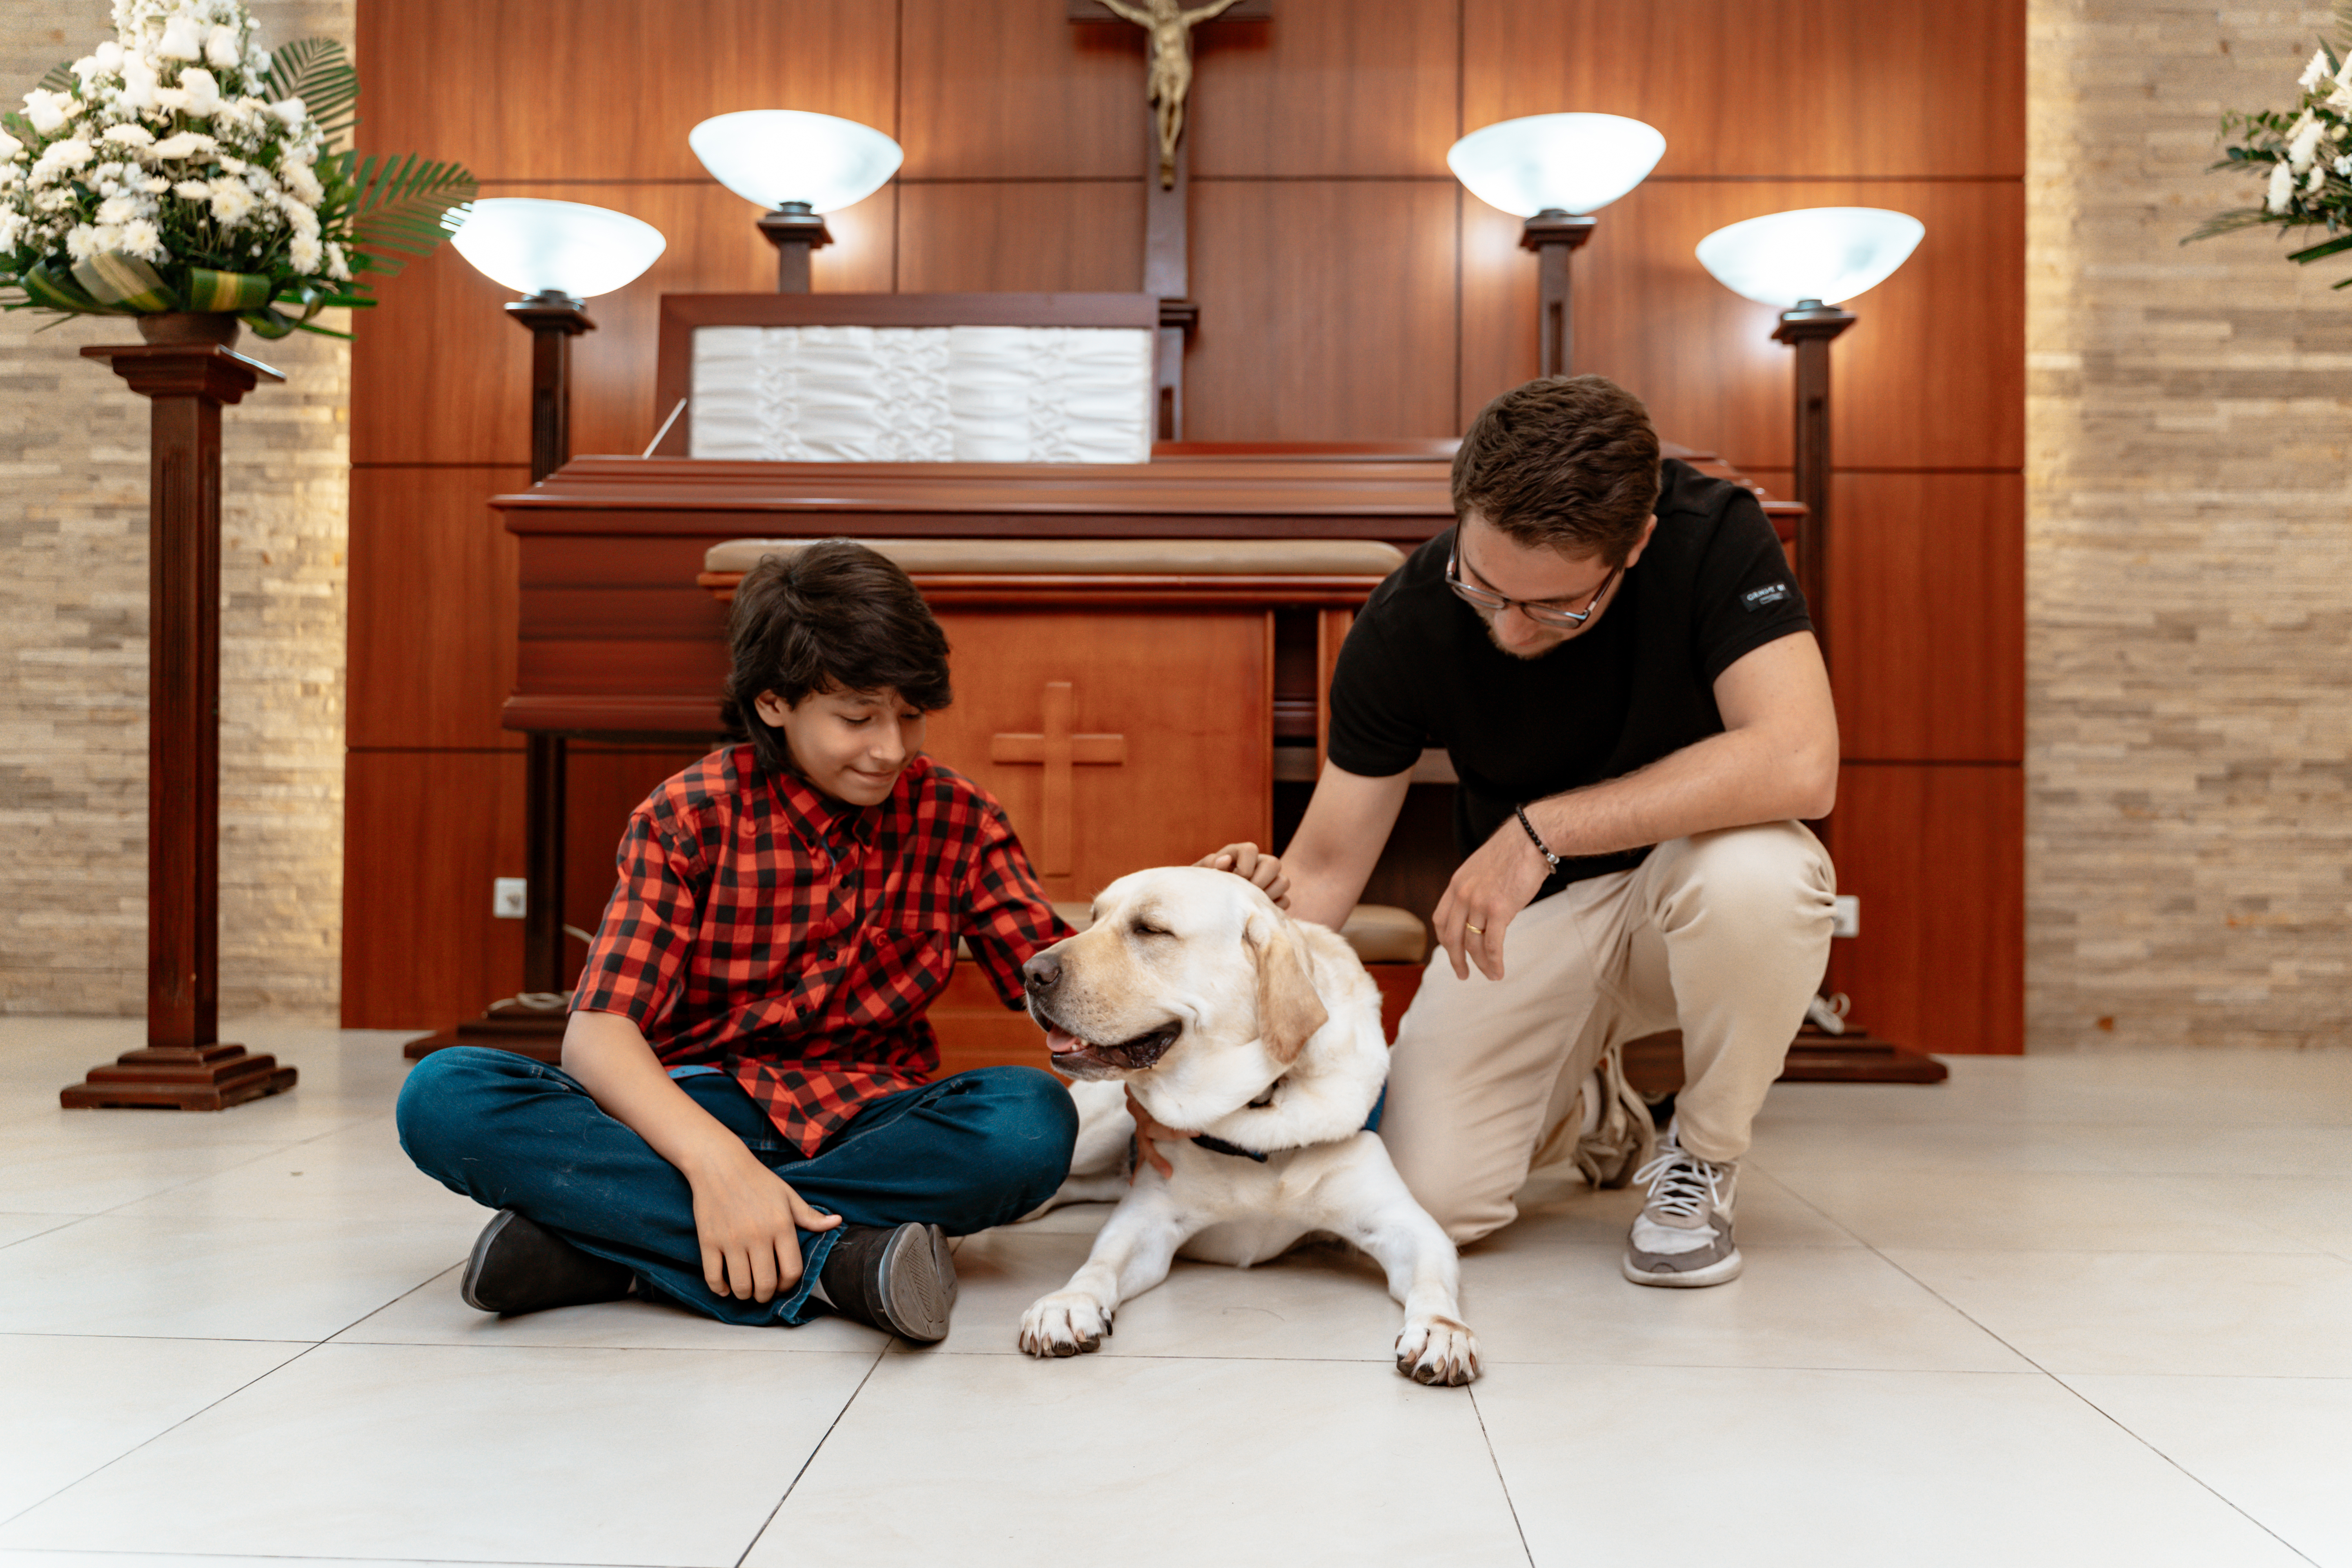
[2025,0,2352,1051]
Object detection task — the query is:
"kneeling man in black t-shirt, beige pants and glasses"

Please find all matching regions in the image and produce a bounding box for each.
[1214,376,1837,1286]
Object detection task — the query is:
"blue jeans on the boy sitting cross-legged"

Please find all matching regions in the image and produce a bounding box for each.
[397,1046,1077,1326]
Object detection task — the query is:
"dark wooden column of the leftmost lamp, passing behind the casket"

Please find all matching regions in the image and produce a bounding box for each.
[506,294,593,1011]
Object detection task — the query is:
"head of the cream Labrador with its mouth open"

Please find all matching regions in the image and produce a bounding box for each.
[1023,865,1329,1126]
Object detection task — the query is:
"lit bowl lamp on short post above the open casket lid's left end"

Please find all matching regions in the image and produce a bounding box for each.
[687,108,906,294]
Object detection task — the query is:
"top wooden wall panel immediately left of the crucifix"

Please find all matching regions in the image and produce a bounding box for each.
[898,0,1150,181]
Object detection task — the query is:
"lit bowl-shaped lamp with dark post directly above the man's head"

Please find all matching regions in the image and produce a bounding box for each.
[1446,115,1665,376]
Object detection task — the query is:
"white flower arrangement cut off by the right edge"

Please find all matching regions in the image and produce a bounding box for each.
[2183,16,2352,289]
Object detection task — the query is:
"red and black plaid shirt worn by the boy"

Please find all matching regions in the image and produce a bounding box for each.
[572,745,1068,1154]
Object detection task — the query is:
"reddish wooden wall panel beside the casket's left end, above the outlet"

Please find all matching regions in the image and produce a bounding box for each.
[343,463,532,752]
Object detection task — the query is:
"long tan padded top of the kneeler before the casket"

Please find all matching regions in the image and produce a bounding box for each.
[703,538,1404,576]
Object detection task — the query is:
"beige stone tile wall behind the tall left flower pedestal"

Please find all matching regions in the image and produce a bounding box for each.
[0,0,353,1020]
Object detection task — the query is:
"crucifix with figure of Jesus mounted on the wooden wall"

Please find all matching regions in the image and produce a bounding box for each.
[1068,0,1272,442]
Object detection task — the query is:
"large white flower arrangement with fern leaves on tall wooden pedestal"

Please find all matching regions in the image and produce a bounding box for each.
[0,0,475,339]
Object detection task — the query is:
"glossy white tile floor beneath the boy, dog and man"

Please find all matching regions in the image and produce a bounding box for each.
[0,1018,2352,1568]
